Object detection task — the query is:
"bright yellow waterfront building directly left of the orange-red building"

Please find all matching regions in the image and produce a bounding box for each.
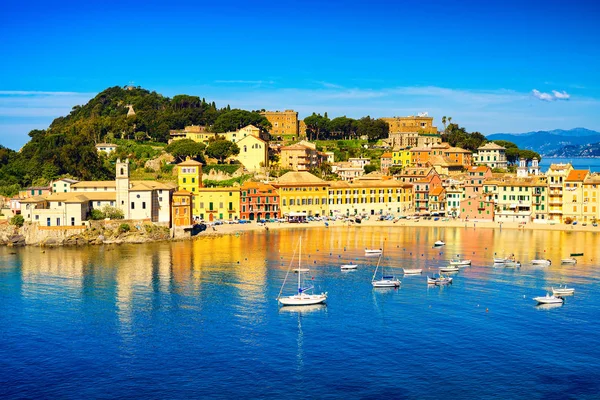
[196,186,240,222]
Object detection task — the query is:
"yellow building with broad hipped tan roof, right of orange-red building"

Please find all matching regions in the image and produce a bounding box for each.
[271,172,330,216]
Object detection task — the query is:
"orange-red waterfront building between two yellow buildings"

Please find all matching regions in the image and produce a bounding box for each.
[240,181,281,221]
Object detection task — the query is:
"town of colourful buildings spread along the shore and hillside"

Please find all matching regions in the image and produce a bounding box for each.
[3,110,600,238]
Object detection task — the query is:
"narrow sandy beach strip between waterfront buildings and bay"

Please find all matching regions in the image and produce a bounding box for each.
[197,219,600,237]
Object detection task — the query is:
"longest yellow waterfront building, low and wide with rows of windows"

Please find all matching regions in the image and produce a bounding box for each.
[328,176,412,216]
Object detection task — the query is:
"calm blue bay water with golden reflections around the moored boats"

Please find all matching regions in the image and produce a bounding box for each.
[0,227,600,399]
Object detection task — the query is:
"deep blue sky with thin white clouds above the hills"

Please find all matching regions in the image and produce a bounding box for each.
[0,0,600,149]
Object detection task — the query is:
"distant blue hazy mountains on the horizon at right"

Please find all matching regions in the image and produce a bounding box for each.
[487,128,600,156]
